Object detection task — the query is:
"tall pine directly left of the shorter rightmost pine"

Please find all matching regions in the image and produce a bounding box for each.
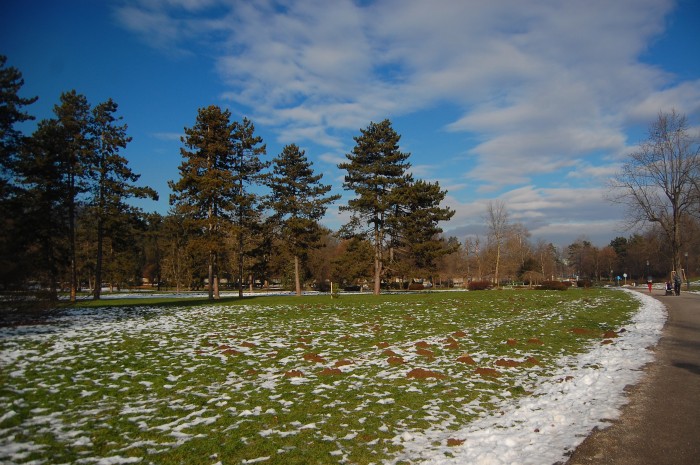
[338,120,412,294]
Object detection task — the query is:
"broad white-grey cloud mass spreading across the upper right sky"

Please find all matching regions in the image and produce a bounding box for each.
[117,0,700,245]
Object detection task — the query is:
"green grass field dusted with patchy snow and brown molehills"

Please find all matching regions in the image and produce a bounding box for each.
[0,289,638,464]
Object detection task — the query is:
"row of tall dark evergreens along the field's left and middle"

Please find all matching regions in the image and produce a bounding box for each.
[0,57,454,301]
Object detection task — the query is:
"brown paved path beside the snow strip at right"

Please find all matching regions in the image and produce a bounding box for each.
[567,290,700,465]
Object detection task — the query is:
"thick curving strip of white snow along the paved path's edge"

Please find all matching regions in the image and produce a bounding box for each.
[391,291,667,465]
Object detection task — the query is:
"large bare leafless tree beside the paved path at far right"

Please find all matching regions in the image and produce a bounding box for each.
[609,110,700,270]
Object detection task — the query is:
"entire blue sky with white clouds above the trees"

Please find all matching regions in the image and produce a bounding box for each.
[0,0,700,245]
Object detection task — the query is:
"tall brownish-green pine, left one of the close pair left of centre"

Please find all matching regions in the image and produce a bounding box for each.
[169,105,240,299]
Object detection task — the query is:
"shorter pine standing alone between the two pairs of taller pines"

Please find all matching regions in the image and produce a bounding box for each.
[270,144,340,295]
